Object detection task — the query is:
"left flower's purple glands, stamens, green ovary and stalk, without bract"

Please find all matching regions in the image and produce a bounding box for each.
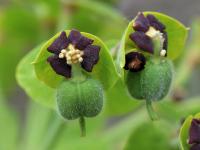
[47,30,103,135]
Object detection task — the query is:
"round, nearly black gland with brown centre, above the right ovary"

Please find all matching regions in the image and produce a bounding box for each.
[124,52,146,72]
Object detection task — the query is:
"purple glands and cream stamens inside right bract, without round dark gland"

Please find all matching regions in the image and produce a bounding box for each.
[129,12,168,57]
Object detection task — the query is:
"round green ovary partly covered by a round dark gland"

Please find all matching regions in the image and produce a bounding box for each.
[126,59,173,100]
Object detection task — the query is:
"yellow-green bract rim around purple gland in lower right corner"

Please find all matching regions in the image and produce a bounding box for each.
[179,113,200,150]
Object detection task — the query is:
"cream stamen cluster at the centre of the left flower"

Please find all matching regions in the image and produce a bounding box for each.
[59,44,84,65]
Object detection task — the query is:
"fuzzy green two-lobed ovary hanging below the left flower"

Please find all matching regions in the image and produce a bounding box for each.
[57,79,103,120]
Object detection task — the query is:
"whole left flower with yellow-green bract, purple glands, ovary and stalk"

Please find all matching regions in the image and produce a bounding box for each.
[33,29,117,135]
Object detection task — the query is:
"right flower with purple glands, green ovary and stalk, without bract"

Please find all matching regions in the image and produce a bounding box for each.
[124,12,173,120]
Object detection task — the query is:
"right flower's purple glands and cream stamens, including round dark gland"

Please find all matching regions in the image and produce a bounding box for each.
[124,12,168,72]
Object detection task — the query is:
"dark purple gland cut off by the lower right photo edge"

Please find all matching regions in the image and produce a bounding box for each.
[189,119,200,150]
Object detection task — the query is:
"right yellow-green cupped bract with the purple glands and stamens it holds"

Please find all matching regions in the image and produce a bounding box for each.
[117,11,188,76]
